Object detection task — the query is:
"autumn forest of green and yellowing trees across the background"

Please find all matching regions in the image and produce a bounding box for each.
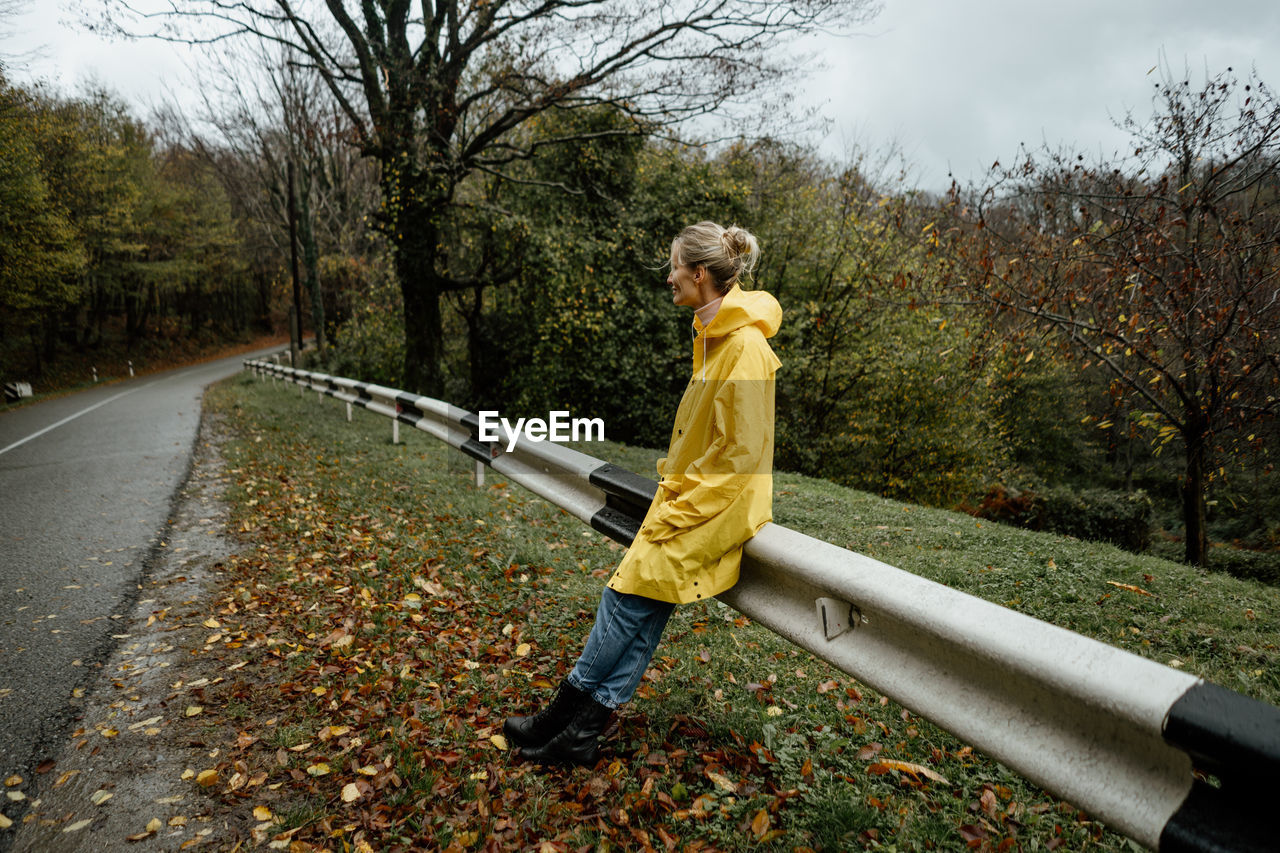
[0,4,1280,583]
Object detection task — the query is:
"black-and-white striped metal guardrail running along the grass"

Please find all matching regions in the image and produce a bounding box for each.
[246,361,1280,853]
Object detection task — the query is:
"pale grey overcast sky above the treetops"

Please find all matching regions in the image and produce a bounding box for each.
[0,0,1280,190]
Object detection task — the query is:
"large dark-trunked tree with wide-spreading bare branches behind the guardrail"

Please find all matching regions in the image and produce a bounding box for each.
[104,0,877,393]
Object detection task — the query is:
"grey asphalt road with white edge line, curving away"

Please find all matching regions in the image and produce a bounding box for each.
[0,347,280,779]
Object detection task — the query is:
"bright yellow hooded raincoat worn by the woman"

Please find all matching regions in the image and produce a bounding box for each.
[609,284,782,605]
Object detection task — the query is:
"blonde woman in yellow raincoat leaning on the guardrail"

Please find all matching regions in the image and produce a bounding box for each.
[503,222,782,765]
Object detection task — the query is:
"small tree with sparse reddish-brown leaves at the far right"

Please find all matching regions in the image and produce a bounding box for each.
[954,69,1280,565]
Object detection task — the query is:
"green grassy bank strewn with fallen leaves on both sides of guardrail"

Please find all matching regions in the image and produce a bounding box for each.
[197,377,1280,850]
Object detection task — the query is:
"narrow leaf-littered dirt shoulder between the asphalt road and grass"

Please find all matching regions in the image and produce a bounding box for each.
[9,415,252,853]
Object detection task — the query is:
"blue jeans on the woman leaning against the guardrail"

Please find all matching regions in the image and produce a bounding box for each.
[568,587,676,710]
